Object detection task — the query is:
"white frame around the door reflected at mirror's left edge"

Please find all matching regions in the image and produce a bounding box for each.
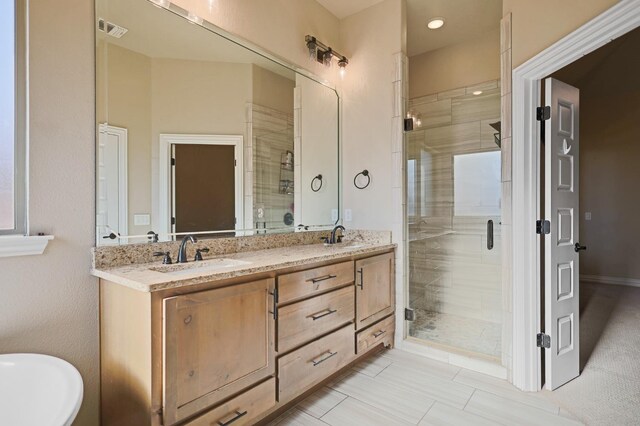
[96,123,129,246]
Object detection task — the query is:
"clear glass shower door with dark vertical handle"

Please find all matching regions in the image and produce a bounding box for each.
[405,89,502,360]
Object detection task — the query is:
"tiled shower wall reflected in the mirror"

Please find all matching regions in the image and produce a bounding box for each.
[251,104,293,228]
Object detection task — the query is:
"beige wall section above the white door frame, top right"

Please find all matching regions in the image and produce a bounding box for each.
[502,0,618,68]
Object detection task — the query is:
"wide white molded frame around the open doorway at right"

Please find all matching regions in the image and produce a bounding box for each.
[511,0,640,391]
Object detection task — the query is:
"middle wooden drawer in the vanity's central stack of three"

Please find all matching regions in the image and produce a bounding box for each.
[277,286,355,352]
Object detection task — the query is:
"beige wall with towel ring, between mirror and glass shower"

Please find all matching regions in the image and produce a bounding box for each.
[340,0,404,231]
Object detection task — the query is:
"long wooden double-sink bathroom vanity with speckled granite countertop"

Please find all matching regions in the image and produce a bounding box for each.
[94,233,395,426]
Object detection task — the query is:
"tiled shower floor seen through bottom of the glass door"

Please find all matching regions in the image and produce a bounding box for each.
[409,308,502,358]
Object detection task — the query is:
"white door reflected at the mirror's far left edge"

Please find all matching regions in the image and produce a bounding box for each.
[96,124,128,245]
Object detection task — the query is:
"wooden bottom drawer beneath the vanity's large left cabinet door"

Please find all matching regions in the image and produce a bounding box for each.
[187,377,276,426]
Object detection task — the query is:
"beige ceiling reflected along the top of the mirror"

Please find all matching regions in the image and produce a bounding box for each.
[96,0,295,79]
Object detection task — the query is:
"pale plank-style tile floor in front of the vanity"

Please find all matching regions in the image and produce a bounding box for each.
[270,349,581,426]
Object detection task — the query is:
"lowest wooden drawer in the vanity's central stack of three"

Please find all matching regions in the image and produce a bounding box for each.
[278,324,355,401]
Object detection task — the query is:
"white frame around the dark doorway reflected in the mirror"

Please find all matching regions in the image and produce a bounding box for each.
[158,133,244,241]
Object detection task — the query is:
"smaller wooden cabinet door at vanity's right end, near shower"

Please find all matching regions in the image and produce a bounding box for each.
[356,253,395,330]
